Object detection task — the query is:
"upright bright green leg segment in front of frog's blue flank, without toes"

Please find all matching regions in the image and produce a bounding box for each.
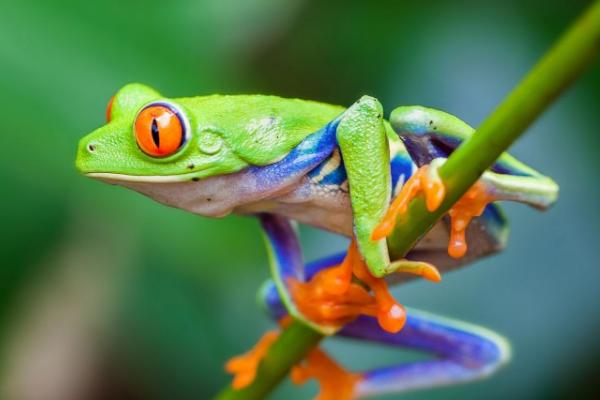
[336,96,391,276]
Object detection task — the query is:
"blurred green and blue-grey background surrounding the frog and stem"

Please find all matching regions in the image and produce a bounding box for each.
[0,0,600,400]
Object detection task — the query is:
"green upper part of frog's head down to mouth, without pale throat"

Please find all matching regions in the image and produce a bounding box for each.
[75,84,247,186]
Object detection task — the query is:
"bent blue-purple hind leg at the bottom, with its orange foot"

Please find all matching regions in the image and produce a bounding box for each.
[262,282,510,398]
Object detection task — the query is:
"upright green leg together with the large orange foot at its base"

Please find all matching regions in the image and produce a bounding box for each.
[290,96,440,332]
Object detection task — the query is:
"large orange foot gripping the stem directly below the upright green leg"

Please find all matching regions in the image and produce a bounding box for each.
[288,240,406,333]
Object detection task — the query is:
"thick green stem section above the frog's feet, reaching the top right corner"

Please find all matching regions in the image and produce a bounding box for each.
[388,1,600,258]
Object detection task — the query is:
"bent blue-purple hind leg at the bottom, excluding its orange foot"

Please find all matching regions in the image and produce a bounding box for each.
[339,316,510,397]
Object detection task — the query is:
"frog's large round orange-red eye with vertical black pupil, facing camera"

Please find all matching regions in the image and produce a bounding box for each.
[134,103,186,157]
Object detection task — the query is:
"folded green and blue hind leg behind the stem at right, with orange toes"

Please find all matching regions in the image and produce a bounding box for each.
[371,106,558,258]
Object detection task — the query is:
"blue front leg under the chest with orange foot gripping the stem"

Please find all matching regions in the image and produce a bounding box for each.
[260,214,422,335]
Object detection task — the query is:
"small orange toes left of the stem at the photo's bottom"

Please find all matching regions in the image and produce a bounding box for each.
[225,331,279,389]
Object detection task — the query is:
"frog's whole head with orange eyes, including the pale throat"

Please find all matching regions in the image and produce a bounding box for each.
[75,84,255,216]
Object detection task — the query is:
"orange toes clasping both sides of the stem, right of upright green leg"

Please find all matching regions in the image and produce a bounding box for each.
[371,165,496,258]
